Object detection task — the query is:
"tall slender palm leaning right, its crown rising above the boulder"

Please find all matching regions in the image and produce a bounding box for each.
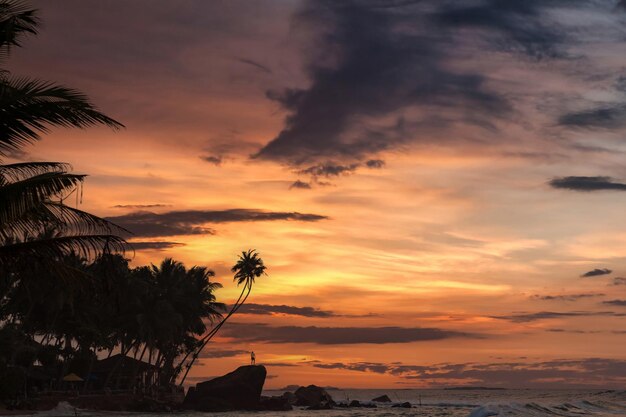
[180,249,267,386]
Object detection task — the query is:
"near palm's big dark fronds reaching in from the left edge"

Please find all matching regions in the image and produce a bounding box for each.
[0,0,125,268]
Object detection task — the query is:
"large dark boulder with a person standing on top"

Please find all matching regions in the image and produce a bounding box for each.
[183,365,267,411]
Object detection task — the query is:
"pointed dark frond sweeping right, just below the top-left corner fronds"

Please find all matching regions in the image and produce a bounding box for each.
[0,78,124,155]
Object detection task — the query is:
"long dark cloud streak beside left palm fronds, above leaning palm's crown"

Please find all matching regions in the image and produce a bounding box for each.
[107,209,327,237]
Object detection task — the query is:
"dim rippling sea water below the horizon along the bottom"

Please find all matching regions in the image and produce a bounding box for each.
[42,389,626,417]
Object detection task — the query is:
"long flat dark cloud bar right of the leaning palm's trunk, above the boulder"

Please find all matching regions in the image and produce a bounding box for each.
[221,323,472,345]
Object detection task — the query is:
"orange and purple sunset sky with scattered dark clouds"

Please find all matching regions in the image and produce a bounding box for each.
[9,0,626,388]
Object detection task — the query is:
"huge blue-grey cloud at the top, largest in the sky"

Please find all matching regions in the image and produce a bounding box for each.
[255,0,512,164]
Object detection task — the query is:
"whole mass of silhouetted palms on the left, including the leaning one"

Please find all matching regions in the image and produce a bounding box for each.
[0,0,266,399]
